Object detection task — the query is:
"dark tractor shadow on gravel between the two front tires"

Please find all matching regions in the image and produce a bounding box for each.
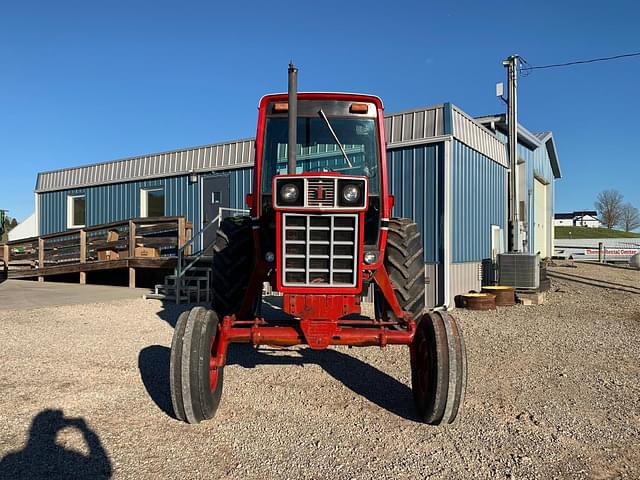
[227,344,418,421]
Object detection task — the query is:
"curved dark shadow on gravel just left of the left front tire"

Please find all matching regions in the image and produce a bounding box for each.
[138,345,176,418]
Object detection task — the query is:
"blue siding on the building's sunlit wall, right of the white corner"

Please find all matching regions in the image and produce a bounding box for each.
[451,140,507,263]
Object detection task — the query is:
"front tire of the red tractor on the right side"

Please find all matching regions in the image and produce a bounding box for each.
[410,312,467,425]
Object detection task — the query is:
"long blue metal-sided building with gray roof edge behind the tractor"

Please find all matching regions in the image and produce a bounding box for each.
[31,103,559,307]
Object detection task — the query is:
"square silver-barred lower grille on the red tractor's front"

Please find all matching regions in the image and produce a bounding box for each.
[282,213,358,288]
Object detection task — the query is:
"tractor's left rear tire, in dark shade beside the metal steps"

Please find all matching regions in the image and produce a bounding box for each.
[211,217,253,317]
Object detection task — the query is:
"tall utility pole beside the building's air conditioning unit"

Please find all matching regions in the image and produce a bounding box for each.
[502,55,521,252]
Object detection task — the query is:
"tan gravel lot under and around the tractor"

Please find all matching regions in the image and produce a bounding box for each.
[0,264,640,479]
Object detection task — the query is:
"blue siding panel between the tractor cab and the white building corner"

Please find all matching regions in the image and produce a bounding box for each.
[387,143,444,263]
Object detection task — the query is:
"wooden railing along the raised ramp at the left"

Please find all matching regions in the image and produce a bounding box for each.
[0,217,193,269]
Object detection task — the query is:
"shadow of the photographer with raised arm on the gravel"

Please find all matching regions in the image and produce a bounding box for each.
[0,410,112,479]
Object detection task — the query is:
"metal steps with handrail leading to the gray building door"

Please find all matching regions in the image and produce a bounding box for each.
[145,207,249,304]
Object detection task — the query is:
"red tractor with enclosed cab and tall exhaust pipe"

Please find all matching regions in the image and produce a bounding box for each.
[170,65,466,425]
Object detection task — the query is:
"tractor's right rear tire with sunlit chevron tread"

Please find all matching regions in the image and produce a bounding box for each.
[384,218,424,320]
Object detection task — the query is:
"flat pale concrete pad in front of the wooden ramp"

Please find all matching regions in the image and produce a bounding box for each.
[0,279,149,310]
